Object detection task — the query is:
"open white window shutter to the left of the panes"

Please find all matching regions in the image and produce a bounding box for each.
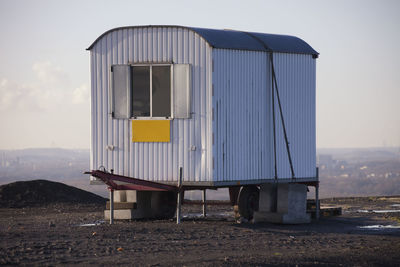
[110,65,131,119]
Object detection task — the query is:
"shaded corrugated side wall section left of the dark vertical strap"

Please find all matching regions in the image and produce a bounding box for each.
[213,49,273,182]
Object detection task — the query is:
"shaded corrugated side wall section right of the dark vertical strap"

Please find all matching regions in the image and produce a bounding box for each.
[274,53,316,178]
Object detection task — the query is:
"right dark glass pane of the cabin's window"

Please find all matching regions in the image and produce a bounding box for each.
[152,66,171,117]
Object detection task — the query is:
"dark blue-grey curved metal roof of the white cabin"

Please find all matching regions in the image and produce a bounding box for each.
[87,25,319,57]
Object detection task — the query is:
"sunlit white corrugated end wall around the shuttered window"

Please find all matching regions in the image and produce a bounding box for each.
[91,27,212,182]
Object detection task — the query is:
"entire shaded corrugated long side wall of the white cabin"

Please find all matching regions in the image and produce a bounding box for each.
[213,49,316,182]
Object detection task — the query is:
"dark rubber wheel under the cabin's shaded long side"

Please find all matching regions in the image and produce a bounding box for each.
[238,186,260,221]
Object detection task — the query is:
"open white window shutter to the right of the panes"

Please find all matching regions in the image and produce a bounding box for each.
[173,64,192,119]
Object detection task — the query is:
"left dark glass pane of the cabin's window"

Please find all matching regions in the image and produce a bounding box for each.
[132,66,150,117]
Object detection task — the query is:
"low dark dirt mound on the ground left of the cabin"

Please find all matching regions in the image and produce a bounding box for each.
[0,180,106,208]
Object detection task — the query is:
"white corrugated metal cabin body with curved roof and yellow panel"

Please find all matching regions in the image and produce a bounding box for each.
[87,26,318,222]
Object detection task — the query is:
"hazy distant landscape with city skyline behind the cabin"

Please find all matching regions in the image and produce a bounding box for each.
[0,148,400,200]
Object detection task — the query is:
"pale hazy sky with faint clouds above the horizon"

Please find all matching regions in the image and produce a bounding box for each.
[0,0,400,149]
